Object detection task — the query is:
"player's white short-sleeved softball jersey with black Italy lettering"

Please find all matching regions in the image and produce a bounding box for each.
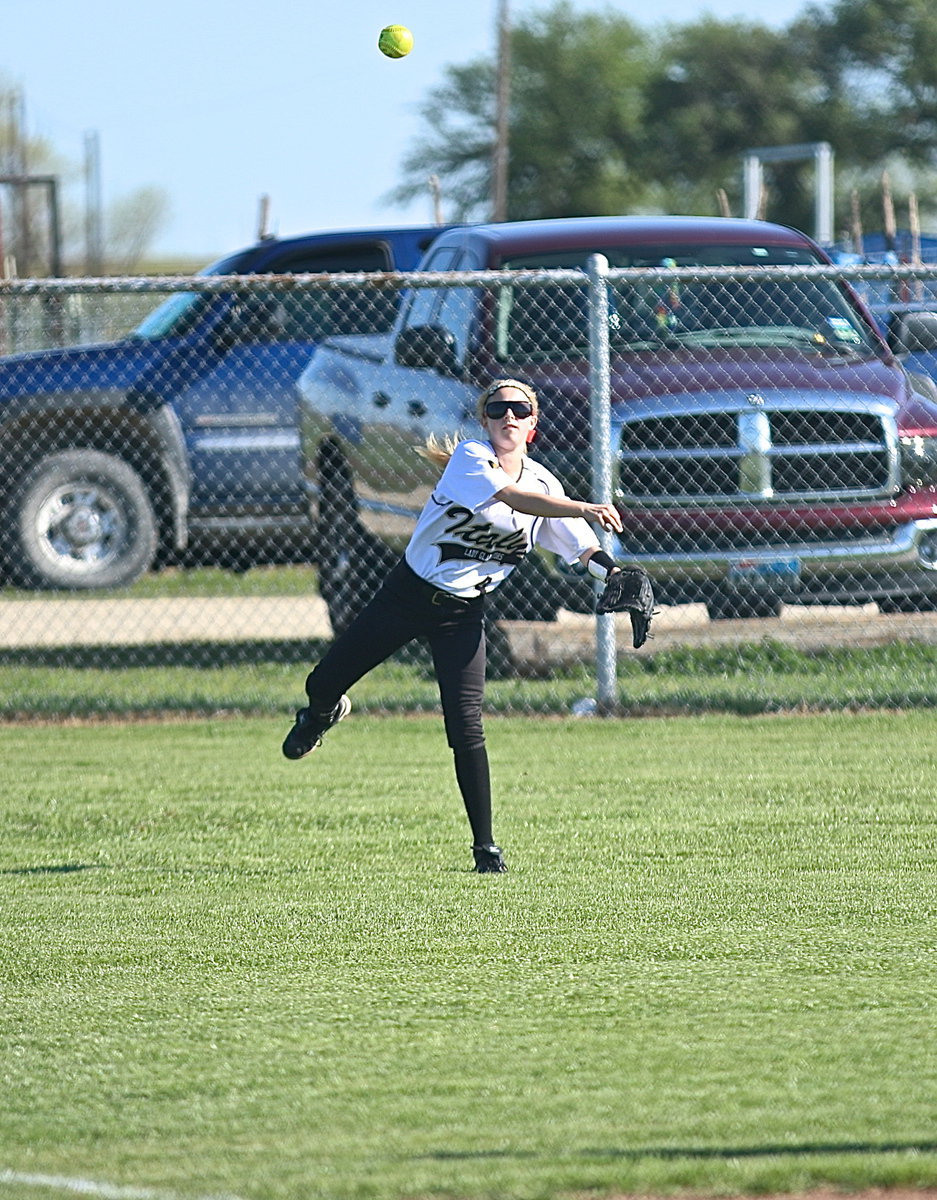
[406,439,597,596]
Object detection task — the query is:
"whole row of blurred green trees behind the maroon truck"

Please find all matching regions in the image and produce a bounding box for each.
[391,0,937,229]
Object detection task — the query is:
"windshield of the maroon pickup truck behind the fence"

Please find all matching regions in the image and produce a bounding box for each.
[497,245,879,361]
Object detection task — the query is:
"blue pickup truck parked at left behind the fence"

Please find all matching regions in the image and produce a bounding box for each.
[0,226,440,589]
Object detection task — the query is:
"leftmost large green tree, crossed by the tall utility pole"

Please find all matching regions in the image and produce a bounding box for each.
[389,2,653,220]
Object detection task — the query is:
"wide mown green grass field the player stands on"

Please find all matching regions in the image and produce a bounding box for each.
[0,710,937,1200]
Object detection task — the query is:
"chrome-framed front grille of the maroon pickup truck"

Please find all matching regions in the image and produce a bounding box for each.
[618,396,897,504]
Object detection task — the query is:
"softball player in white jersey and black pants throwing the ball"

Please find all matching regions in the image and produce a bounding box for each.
[283,379,621,874]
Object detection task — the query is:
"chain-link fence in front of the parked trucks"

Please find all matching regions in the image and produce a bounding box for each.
[0,258,937,713]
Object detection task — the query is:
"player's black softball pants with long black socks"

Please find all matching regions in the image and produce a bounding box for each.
[306,560,494,846]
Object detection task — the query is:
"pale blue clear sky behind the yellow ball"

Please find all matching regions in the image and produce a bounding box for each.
[0,0,806,263]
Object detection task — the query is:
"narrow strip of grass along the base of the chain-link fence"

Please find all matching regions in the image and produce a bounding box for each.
[0,641,937,720]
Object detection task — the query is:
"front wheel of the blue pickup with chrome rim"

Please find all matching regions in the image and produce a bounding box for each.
[5,450,158,588]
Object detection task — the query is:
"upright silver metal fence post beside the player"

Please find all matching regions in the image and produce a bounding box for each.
[588,254,618,714]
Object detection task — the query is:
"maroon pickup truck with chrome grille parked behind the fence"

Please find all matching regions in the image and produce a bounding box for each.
[300,217,937,617]
